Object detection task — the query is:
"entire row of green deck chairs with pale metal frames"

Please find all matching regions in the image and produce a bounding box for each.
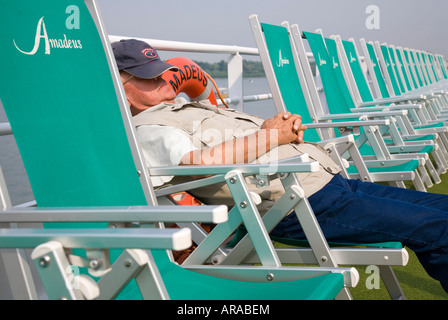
[0,0,447,300]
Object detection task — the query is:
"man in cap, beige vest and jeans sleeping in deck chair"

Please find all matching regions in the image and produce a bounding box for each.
[112,39,448,291]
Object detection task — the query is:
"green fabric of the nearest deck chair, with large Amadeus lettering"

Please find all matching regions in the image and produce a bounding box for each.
[0,0,344,299]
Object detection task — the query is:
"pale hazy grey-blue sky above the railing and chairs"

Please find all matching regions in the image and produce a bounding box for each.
[97,0,448,61]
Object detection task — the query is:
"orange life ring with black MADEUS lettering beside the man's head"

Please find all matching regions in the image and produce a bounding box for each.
[162,57,218,106]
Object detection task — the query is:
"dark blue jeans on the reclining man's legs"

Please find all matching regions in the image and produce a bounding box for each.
[271,175,448,292]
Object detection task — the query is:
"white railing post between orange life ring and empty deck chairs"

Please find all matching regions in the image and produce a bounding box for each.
[227,53,244,112]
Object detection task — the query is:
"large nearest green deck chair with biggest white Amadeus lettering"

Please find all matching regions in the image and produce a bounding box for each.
[0,0,357,300]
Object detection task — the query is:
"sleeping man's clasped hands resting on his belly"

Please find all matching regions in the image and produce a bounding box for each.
[261,112,306,145]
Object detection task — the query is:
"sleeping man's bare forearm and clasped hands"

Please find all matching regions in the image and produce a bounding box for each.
[180,112,306,165]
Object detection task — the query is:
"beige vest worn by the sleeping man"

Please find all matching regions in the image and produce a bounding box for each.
[133,102,341,206]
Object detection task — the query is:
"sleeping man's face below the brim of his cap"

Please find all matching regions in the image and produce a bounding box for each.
[122,73,177,115]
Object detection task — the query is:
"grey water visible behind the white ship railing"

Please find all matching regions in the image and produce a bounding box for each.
[0,78,276,205]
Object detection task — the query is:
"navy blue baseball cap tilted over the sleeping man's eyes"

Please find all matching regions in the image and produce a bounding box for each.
[112,39,178,79]
